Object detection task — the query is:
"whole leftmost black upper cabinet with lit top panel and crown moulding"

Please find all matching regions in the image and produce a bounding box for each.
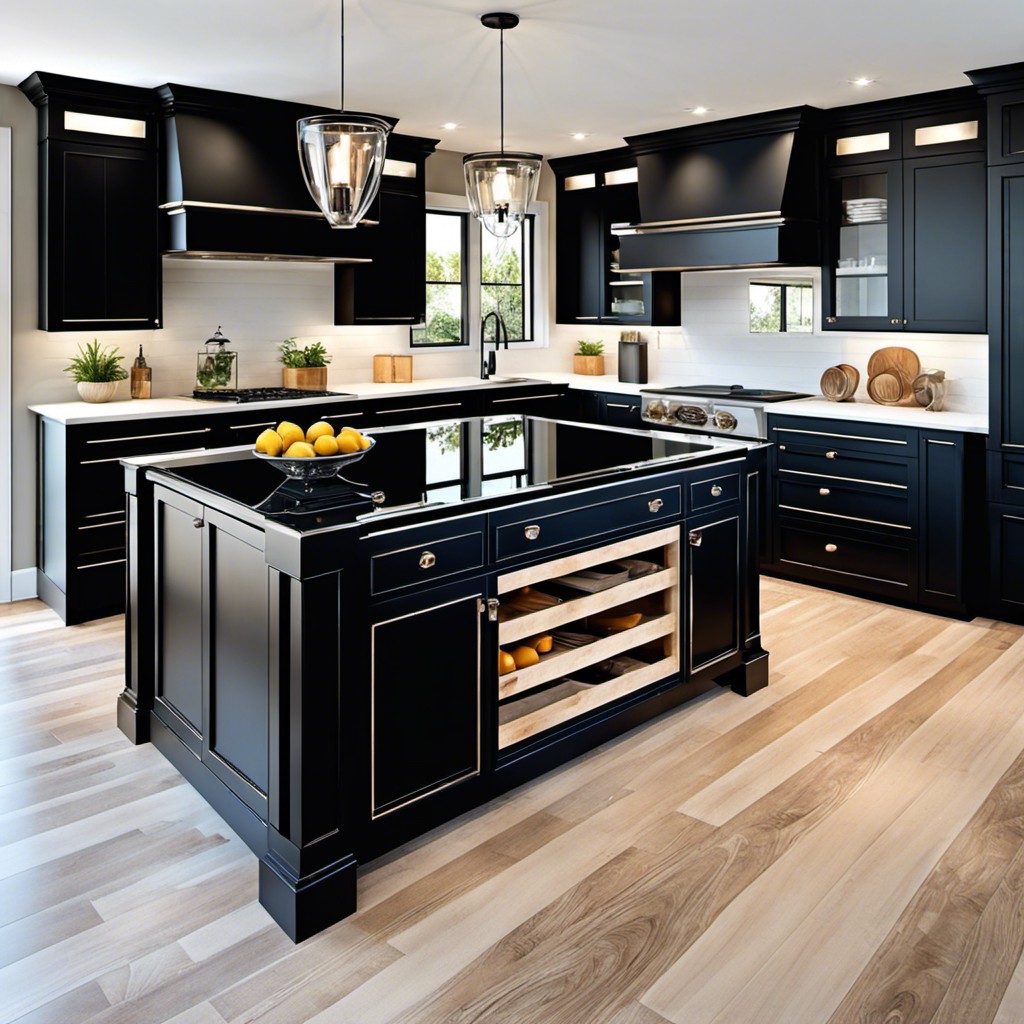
[22,74,161,331]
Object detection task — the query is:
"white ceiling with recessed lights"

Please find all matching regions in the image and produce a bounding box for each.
[0,0,1024,157]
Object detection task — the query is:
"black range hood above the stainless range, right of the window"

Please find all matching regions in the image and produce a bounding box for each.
[612,106,822,272]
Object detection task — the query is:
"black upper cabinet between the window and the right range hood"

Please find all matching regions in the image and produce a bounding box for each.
[551,150,681,327]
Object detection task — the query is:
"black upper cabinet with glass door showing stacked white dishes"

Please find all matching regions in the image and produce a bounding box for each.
[822,90,987,333]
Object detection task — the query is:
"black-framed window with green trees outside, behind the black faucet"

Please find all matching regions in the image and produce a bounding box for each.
[410,210,544,348]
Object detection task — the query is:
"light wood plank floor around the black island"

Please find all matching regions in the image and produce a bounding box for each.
[6,580,1024,1024]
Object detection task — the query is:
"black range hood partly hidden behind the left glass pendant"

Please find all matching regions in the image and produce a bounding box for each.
[157,85,395,263]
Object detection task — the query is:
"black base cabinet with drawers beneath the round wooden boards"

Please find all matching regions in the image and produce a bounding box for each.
[765,416,984,615]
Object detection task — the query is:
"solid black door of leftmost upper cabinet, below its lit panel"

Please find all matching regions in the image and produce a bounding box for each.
[39,141,161,331]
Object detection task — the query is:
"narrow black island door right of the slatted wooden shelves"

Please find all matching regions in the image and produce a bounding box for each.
[686,515,741,672]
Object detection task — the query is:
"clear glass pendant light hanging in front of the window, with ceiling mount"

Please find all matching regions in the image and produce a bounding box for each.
[463,14,544,239]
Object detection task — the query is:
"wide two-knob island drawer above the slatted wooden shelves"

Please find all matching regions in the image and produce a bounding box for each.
[492,485,682,561]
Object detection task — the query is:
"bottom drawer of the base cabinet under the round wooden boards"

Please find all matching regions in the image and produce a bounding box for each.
[777,520,916,600]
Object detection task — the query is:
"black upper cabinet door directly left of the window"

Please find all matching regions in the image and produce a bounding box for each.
[335,188,427,325]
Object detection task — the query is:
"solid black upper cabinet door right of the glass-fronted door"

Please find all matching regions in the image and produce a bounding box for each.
[903,156,986,334]
